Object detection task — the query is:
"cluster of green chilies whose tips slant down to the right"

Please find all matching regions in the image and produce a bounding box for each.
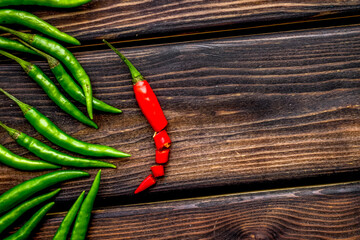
[0,8,130,170]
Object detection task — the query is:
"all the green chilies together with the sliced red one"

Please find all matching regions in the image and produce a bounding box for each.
[0,0,171,240]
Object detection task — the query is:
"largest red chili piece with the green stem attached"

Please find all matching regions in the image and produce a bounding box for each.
[103,40,168,132]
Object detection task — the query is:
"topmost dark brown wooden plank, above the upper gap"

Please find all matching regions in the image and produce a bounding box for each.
[7,0,360,43]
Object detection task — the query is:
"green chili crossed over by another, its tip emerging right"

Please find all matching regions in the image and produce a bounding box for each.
[19,40,122,113]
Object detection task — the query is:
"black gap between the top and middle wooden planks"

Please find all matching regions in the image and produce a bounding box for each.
[68,15,360,52]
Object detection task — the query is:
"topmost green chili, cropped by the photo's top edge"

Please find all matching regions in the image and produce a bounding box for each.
[0,0,91,8]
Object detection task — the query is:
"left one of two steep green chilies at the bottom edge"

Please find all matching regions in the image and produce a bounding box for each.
[53,191,85,240]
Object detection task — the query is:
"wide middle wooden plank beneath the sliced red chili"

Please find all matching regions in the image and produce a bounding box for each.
[0,26,360,204]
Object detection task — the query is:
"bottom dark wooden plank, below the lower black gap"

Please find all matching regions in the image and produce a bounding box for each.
[27,183,360,240]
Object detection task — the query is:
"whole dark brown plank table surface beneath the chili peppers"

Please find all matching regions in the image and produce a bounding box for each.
[0,0,360,240]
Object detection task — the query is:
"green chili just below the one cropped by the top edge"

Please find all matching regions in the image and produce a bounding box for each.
[0,9,80,45]
